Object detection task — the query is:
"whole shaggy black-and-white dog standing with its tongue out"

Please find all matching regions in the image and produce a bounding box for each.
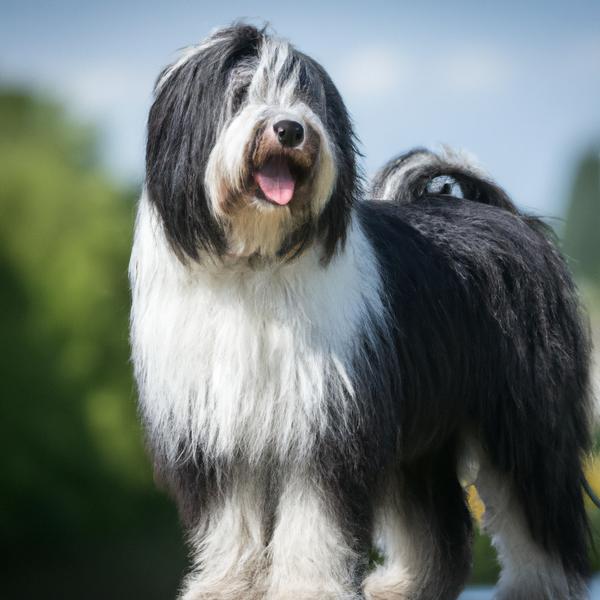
[130,25,589,600]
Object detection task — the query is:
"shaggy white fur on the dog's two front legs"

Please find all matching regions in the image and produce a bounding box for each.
[181,471,360,600]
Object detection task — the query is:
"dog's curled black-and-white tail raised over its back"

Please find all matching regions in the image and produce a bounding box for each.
[370,148,518,213]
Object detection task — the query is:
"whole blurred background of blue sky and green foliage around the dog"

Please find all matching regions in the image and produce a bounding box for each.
[0,0,600,600]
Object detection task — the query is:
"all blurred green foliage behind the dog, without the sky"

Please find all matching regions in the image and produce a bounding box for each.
[0,89,600,600]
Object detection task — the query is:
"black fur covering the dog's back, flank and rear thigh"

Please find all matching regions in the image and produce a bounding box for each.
[359,151,590,575]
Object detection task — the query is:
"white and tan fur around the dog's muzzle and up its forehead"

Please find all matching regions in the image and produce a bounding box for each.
[205,40,336,256]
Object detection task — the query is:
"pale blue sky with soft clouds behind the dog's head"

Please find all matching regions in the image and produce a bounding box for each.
[0,0,600,215]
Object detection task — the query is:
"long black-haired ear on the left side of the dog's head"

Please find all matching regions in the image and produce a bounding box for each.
[146,25,264,259]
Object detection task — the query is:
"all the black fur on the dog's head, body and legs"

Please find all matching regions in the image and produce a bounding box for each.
[136,26,590,600]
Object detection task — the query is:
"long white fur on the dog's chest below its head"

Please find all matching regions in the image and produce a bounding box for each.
[130,200,382,462]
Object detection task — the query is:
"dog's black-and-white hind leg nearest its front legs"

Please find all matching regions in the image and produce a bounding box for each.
[363,451,471,600]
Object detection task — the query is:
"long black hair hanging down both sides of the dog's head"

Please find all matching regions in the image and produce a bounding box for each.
[146,25,361,262]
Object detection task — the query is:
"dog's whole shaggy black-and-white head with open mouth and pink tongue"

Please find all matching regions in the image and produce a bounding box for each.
[146,25,358,260]
